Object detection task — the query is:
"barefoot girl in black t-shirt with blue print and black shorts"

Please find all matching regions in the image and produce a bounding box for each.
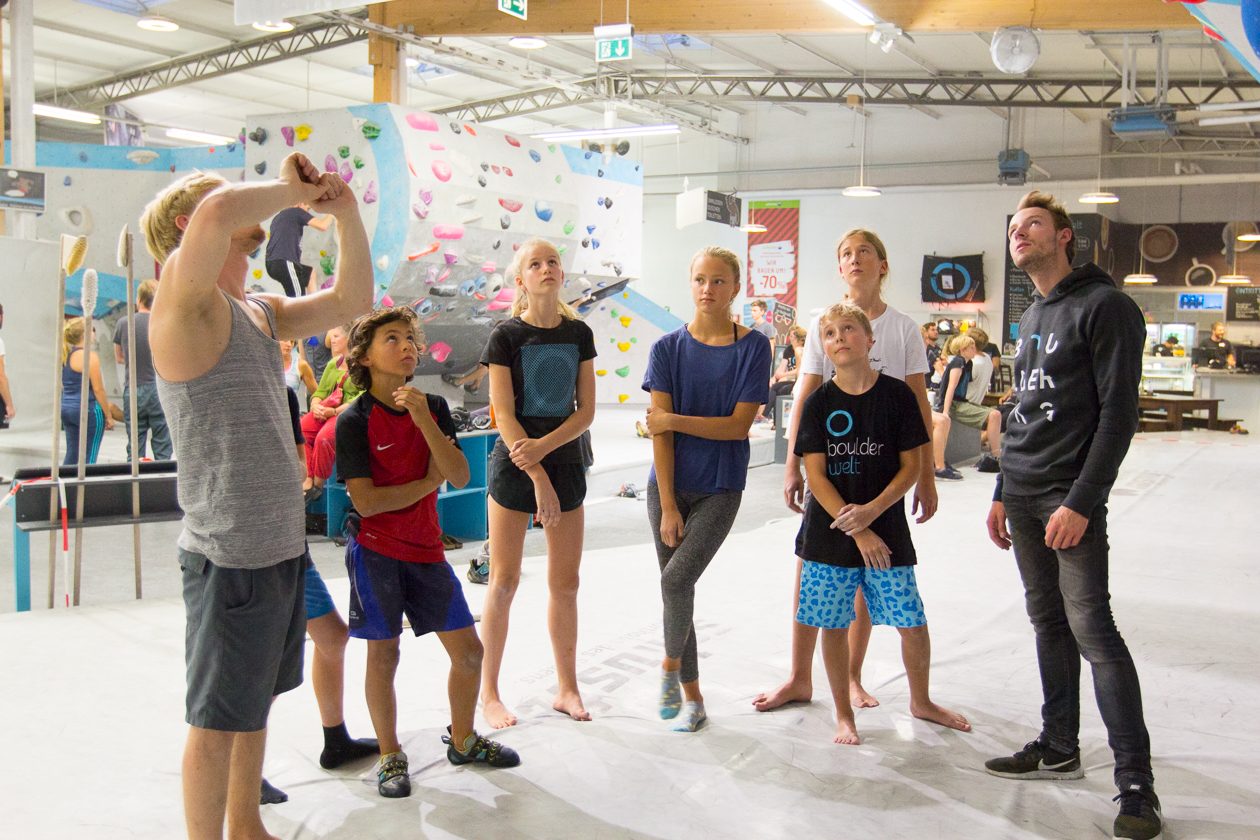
[481,239,595,729]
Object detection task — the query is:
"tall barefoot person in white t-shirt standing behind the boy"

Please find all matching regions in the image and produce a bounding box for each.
[752,228,970,730]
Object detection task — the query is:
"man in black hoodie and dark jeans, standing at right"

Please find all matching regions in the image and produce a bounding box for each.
[985,190,1162,840]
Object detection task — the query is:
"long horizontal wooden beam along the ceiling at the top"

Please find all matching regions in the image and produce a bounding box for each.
[372,0,1200,38]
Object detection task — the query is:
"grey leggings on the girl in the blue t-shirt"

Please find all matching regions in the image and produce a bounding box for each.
[648,481,743,683]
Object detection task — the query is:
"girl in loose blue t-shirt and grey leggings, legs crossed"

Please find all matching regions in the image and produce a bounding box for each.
[643,247,770,732]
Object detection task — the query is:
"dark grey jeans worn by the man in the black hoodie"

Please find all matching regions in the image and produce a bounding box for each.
[1002,490,1154,790]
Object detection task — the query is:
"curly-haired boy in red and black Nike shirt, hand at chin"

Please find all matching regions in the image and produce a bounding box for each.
[336,306,520,798]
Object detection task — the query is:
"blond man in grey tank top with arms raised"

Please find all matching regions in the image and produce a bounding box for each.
[141,154,372,840]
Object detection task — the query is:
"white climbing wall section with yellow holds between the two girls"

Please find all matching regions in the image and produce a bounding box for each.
[586,287,683,406]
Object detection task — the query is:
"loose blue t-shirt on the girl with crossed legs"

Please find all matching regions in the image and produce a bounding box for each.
[643,325,770,492]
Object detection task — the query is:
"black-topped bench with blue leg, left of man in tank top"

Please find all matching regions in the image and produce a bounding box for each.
[13,461,184,612]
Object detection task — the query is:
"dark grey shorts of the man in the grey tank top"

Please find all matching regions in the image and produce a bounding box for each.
[179,549,306,732]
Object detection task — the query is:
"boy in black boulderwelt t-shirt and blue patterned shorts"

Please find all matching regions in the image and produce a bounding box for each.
[796,304,971,744]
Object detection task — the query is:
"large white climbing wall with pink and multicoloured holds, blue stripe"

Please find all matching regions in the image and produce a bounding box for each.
[246,105,643,385]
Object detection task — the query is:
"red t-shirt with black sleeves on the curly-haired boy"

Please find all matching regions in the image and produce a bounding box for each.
[336,392,459,563]
